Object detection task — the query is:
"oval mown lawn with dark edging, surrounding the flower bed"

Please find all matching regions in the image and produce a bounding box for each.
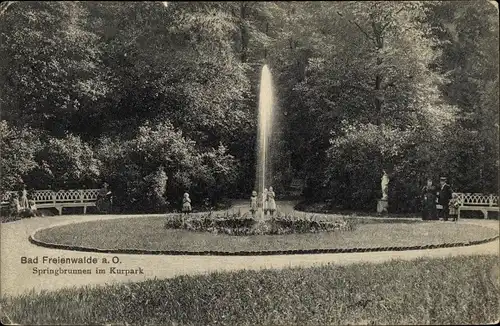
[35,216,498,252]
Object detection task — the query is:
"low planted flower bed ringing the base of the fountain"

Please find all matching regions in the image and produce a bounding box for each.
[165,214,355,235]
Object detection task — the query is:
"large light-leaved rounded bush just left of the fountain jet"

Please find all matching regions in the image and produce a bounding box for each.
[97,122,237,212]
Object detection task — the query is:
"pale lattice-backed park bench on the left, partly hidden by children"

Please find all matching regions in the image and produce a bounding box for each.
[2,189,99,215]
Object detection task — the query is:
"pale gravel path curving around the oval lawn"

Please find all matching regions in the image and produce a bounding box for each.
[0,202,500,297]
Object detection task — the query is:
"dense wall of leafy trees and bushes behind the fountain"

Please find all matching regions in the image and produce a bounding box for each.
[0,1,499,210]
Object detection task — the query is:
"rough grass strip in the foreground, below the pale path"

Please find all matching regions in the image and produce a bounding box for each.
[1,256,500,326]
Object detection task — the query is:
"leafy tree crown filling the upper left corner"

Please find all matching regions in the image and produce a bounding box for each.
[0,2,107,136]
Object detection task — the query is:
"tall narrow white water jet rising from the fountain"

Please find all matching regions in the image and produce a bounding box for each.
[256,65,274,220]
